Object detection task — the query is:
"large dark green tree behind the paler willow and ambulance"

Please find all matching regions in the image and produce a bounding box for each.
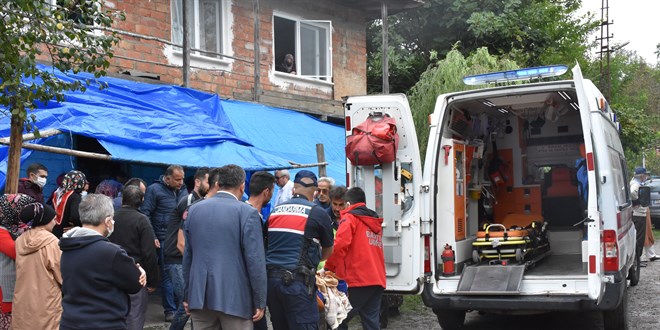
[367,0,597,92]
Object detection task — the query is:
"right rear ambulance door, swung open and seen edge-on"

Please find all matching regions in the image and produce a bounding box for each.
[572,64,605,303]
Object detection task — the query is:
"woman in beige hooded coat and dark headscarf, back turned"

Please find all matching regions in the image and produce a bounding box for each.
[11,203,62,330]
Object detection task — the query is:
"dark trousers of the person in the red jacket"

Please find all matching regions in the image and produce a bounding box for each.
[339,285,385,330]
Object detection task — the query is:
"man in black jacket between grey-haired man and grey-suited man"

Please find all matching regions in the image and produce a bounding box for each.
[109,185,160,330]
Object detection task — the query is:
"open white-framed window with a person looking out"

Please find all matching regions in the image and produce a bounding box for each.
[273,15,332,82]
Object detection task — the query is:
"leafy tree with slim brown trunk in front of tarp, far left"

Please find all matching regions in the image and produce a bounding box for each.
[0,0,124,193]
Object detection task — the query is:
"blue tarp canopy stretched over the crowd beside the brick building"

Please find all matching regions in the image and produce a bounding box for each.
[0,66,345,184]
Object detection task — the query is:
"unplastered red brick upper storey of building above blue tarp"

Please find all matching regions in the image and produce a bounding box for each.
[98,0,421,119]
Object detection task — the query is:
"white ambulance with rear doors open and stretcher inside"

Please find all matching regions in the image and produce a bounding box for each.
[345,66,640,329]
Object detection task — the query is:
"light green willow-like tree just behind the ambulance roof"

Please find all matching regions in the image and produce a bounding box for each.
[409,47,518,159]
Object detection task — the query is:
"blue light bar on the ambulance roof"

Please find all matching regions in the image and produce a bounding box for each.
[463,65,568,86]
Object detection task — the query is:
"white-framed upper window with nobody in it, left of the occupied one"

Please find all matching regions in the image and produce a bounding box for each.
[172,0,226,58]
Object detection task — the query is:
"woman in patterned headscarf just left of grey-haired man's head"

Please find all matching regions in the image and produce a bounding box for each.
[53,170,87,238]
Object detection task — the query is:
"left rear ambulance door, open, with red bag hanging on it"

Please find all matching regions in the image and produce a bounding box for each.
[344,94,423,293]
